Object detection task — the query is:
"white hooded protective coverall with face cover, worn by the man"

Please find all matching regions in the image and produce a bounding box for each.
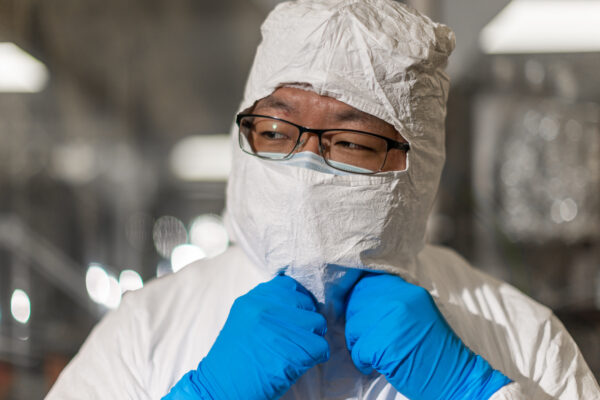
[48,0,600,400]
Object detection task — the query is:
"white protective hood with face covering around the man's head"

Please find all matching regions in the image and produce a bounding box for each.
[226,0,454,302]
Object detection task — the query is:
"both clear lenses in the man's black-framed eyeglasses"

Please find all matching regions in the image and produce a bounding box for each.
[240,116,387,171]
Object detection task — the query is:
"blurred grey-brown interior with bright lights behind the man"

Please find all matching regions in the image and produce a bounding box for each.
[0,0,600,400]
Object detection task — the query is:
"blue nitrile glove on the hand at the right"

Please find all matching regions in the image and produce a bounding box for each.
[345,273,511,400]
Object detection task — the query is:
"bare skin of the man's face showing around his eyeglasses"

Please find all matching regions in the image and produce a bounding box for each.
[252,87,406,171]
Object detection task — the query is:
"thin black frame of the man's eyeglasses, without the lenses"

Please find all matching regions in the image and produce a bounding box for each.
[235,113,410,175]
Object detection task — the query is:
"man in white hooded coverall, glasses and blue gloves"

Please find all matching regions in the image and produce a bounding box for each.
[48,0,600,400]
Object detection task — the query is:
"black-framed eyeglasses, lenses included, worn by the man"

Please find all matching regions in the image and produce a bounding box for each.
[236,114,410,174]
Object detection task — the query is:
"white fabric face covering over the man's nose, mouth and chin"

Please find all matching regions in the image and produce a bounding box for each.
[226,149,428,308]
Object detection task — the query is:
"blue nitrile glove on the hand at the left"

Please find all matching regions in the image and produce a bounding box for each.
[163,275,329,400]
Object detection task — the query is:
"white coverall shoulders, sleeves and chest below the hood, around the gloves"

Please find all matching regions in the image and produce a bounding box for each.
[47,246,600,400]
